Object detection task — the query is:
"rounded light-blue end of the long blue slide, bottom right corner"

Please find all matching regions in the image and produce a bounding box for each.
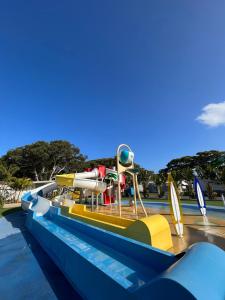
[163,243,225,299]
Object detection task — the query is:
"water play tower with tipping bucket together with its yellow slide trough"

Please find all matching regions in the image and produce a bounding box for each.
[53,144,173,250]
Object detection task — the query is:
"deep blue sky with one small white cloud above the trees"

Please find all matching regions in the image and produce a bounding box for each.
[0,0,225,170]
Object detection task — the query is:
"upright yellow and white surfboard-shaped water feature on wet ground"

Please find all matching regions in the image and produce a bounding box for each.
[168,173,184,237]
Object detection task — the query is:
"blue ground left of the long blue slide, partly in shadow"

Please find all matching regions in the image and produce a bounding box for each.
[0,212,81,300]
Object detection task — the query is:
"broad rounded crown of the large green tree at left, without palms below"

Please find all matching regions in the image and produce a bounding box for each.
[2,140,86,180]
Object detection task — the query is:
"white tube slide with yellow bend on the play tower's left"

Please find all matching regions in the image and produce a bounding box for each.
[56,169,106,193]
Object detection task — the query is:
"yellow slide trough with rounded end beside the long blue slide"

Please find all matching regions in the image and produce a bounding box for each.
[61,204,173,250]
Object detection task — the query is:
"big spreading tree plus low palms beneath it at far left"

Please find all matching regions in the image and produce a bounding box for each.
[0,140,87,206]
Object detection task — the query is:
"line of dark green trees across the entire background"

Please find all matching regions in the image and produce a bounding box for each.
[0,140,225,200]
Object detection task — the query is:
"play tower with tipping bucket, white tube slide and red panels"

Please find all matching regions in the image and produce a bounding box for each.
[56,144,147,217]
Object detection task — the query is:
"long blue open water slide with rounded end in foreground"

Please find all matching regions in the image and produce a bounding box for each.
[22,190,225,300]
